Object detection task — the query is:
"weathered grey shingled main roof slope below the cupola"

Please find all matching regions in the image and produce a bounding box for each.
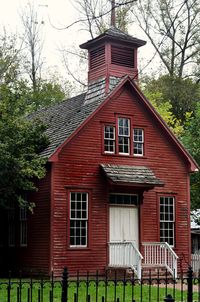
[31,77,124,157]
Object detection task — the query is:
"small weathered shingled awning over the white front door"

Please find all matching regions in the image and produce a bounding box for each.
[101,164,164,187]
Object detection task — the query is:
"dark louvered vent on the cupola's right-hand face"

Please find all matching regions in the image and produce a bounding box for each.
[111,45,134,68]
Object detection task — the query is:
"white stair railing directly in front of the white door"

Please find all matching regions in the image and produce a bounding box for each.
[109,241,143,279]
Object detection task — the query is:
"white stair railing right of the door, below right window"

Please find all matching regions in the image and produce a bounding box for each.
[142,242,178,278]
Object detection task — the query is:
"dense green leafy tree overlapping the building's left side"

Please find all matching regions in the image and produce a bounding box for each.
[0,82,48,208]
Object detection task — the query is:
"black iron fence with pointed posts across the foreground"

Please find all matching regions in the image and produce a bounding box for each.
[0,268,200,302]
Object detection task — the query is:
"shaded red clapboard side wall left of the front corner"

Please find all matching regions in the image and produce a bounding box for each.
[19,168,51,274]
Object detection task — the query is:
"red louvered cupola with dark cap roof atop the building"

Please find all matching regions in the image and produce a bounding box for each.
[80,26,146,92]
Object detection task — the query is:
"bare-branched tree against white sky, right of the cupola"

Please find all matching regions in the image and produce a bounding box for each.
[132,0,200,77]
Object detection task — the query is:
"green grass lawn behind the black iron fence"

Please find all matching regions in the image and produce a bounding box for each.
[0,279,199,302]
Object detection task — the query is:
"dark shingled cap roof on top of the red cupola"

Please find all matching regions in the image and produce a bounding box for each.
[80,26,146,49]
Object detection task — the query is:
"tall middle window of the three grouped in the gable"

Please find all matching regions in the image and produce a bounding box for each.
[118,118,130,154]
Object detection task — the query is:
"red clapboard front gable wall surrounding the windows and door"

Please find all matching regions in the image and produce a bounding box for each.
[48,90,189,274]
